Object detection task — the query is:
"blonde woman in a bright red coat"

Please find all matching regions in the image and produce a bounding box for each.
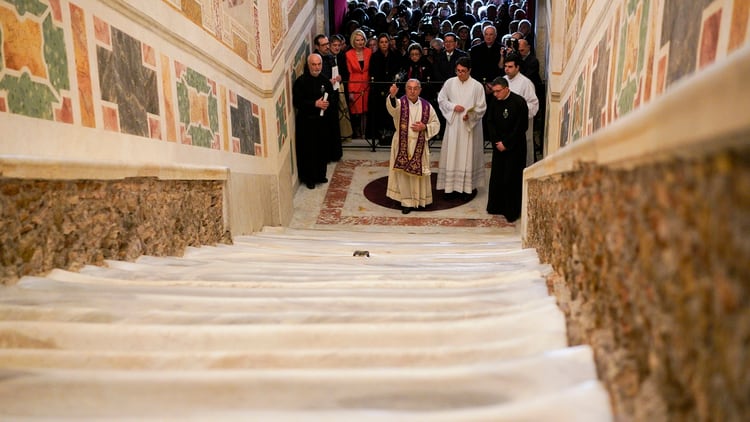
[346,29,372,137]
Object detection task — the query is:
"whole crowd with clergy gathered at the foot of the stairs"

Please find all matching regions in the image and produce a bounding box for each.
[293,0,544,221]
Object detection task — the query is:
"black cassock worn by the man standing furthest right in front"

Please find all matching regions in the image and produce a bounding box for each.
[486,92,529,221]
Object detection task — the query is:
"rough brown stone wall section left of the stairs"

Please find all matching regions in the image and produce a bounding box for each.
[0,177,231,284]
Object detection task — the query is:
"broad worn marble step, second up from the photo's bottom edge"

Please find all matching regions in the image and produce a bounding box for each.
[0,346,596,418]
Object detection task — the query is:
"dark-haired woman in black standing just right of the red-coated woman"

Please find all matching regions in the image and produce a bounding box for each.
[366,33,402,145]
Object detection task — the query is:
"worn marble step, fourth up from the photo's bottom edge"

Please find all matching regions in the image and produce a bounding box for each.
[0,292,555,324]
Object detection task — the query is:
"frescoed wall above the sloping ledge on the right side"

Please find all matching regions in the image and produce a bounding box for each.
[549,0,750,146]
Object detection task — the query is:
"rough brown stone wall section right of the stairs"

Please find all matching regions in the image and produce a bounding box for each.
[527,146,750,421]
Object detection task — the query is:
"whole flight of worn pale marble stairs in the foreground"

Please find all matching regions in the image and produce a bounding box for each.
[0,228,612,422]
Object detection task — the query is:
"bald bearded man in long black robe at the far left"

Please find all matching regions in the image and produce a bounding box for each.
[292,53,338,189]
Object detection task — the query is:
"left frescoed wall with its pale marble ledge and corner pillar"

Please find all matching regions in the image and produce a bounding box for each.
[0,0,316,234]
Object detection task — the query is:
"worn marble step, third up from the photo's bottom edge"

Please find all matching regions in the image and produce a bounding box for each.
[0,306,565,351]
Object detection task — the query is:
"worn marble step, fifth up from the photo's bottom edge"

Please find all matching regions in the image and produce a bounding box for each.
[7,277,548,304]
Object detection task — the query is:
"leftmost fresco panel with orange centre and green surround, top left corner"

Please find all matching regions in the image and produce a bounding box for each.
[0,0,74,123]
